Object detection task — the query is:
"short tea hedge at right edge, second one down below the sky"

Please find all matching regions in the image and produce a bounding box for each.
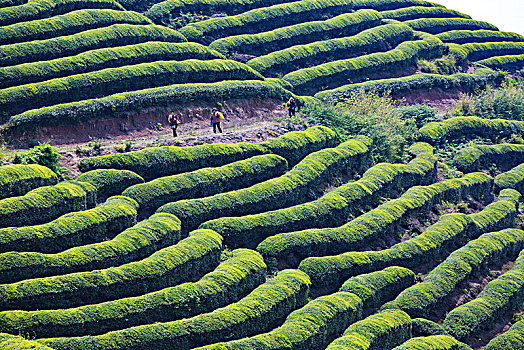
[448,41,524,61]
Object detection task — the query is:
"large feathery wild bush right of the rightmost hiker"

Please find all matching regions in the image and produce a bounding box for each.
[301,90,415,162]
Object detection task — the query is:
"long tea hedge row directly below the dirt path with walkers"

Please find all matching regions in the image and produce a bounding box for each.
[79,126,337,179]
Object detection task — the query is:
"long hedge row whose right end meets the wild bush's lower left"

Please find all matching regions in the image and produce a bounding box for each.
[157,138,371,235]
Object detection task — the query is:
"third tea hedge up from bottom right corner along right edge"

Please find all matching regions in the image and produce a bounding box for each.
[382,229,524,318]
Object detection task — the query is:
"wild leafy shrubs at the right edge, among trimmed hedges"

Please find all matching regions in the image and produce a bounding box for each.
[454,84,524,121]
